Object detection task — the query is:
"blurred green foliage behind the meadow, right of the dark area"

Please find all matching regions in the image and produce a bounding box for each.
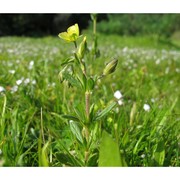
[94,14,180,37]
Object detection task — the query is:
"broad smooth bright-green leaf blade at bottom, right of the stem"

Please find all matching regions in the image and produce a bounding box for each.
[98,131,127,167]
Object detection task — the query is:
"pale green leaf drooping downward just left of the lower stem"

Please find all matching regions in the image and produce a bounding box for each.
[69,120,83,143]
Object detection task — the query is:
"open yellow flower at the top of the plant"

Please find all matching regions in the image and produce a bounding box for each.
[58,24,79,42]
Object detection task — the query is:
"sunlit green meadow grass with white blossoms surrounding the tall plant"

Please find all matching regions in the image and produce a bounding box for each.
[0,35,180,166]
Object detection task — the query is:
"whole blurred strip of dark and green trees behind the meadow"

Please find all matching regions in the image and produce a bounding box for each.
[0,14,180,39]
